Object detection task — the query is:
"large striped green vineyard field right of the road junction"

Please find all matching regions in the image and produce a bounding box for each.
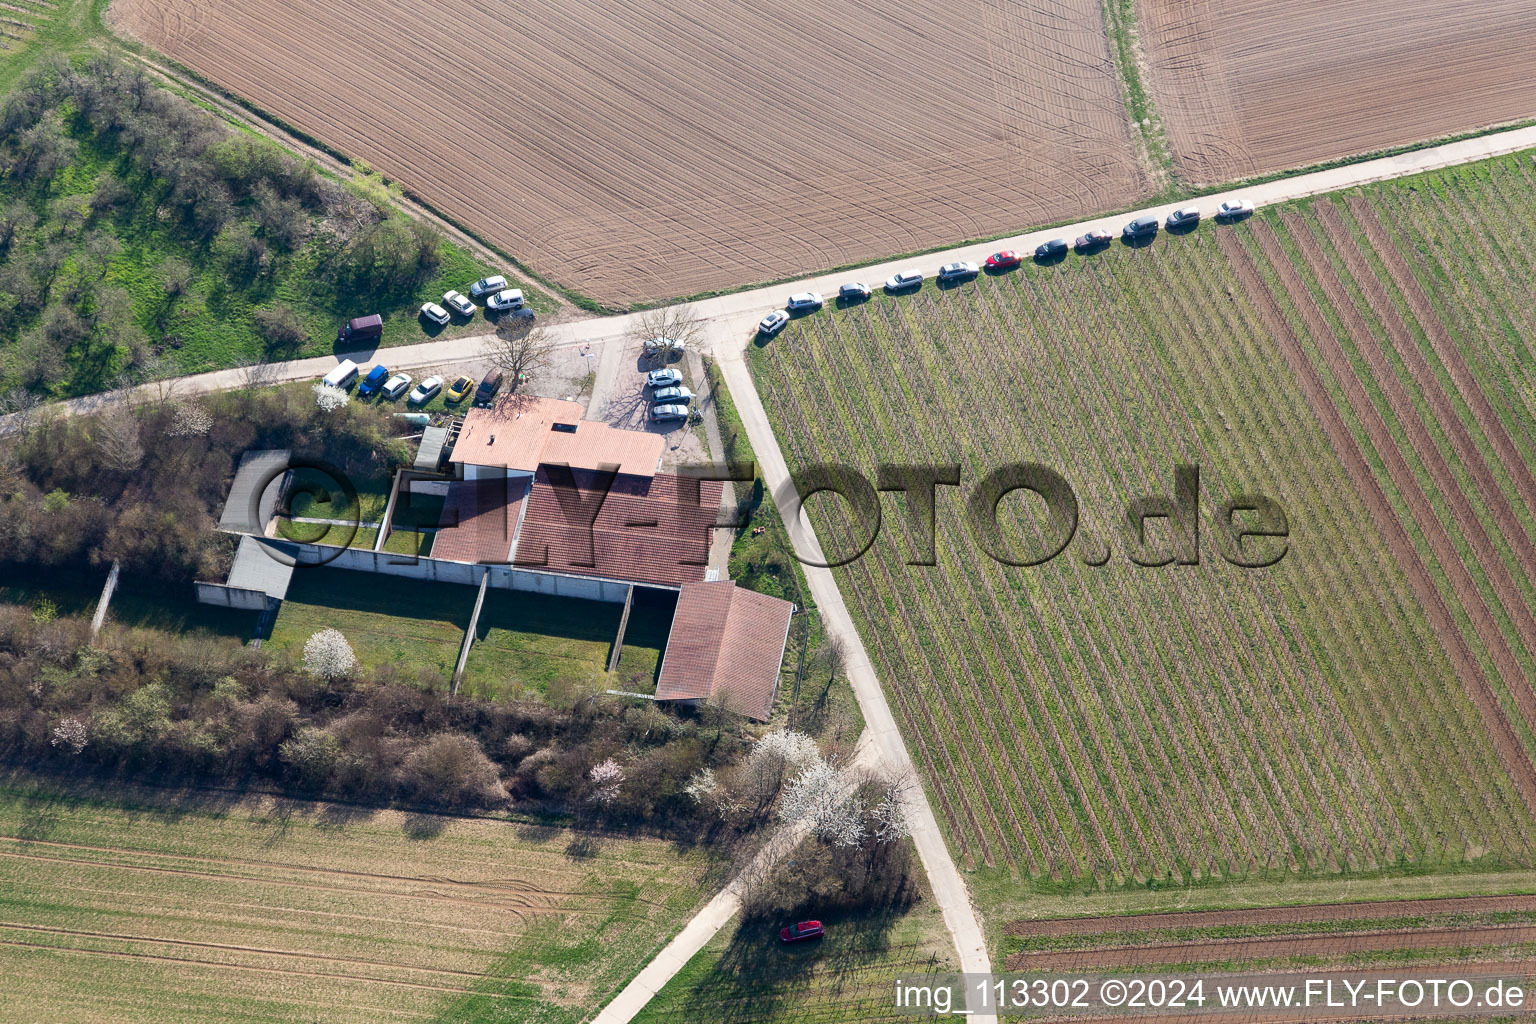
[751,145,1536,945]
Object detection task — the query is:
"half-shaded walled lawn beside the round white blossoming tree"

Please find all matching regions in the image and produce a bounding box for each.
[267,568,475,677]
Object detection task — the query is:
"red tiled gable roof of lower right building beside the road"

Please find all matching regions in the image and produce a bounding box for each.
[656,580,794,722]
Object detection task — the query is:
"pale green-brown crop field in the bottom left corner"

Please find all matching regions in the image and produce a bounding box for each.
[0,777,722,1024]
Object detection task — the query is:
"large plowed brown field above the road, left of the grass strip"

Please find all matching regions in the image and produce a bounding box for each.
[112,0,1144,304]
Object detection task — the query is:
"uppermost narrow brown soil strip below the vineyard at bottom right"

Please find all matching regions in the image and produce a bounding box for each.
[1006,895,1536,938]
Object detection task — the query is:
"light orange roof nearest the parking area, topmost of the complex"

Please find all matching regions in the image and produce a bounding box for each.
[449,395,665,476]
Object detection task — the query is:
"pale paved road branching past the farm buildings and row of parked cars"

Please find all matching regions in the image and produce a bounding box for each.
[12,127,1536,1019]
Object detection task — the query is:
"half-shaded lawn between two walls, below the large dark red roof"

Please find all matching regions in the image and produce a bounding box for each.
[459,590,624,700]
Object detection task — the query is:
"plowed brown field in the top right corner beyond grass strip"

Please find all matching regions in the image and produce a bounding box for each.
[1137,0,1536,183]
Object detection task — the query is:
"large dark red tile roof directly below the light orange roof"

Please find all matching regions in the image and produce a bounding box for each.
[516,467,722,586]
